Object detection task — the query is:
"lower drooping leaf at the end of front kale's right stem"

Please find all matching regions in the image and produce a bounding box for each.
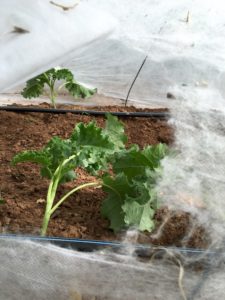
[101,173,157,232]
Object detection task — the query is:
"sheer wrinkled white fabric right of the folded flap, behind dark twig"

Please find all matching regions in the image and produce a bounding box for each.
[62,0,225,106]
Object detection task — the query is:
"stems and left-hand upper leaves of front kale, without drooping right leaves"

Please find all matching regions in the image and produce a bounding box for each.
[12,115,126,236]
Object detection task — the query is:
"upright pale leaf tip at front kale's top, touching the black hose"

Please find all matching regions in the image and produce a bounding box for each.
[103,114,127,150]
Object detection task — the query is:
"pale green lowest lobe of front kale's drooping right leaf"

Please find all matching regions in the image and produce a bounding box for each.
[122,198,155,232]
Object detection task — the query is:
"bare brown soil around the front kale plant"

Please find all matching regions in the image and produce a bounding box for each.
[0,105,206,247]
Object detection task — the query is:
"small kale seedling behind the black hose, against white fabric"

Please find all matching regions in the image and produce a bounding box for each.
[21,68,96,108]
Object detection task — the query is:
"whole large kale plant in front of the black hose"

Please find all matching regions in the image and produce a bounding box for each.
[12,114,168,236]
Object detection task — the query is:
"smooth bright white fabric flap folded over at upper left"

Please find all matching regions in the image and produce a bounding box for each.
[0,0,115,91]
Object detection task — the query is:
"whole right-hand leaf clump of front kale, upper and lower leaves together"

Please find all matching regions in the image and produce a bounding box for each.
[100,144,168,231]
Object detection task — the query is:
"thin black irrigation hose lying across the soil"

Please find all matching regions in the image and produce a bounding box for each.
[0,106,170,119]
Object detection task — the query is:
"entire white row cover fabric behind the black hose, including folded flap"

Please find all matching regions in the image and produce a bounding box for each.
[0,0,225,106]
